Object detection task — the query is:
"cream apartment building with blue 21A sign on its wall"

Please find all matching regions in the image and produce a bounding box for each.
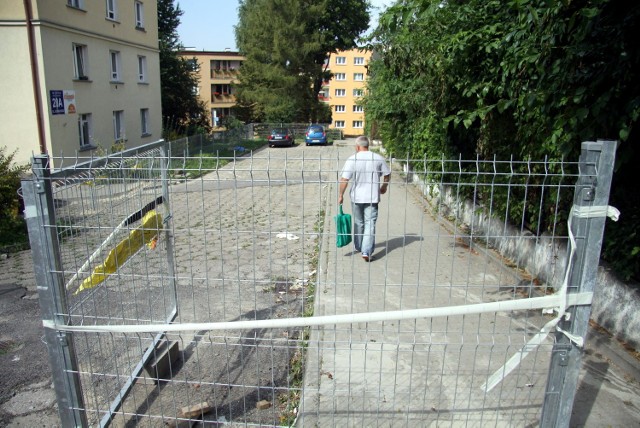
[0,0,162,163]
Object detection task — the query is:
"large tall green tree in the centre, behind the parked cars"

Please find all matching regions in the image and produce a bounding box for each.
[235,0,369,122]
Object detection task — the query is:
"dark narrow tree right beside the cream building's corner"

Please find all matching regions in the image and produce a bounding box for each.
[158,0,211,135]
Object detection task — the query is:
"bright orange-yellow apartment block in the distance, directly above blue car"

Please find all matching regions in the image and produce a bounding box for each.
[319,49,371,136]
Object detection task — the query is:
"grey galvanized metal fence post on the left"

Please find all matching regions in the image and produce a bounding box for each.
[22,155,88,427]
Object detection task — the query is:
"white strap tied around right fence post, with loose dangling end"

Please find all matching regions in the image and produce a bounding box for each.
[480,205,620,392]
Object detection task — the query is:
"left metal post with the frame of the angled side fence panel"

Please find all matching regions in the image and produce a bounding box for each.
[22,140,178,426]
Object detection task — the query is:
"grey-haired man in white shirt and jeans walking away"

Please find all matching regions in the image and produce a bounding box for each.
[338,136,391,262]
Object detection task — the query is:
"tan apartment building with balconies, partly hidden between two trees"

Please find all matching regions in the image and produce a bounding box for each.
[180,50,245,128]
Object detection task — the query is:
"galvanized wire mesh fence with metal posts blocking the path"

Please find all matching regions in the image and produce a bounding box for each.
[23,141,615,426]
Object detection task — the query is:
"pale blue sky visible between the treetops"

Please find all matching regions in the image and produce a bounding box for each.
[175,0,393,51]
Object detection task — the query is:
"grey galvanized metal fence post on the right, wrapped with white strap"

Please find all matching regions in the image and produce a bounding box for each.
[540,140,617,427]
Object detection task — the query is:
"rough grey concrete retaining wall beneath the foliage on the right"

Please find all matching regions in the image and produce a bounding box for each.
[403,164,640,349]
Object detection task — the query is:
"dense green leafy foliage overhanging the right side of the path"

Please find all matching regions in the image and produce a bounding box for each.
[364,0,640,277]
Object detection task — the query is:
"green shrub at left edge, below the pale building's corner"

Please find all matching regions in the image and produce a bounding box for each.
[0,147,28,248]
